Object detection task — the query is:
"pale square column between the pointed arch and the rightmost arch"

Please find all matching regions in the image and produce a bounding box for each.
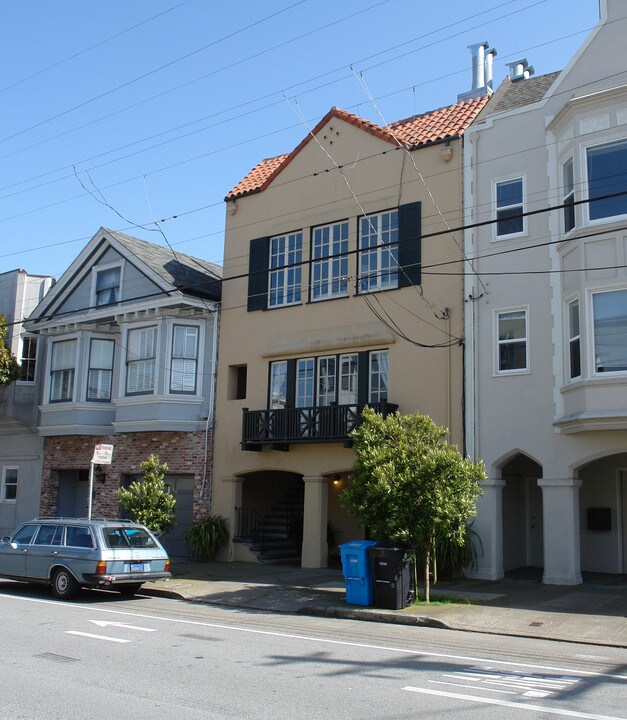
[538,478,581,585]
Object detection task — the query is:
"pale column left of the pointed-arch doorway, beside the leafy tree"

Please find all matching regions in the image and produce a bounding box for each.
[467,478,505,580]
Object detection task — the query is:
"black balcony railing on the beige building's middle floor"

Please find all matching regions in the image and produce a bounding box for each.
[242,401,398,450]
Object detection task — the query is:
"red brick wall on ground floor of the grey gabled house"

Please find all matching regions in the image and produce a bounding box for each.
[40,432,212,520]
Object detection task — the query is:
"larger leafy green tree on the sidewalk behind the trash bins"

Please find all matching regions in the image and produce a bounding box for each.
[340,408,485,602]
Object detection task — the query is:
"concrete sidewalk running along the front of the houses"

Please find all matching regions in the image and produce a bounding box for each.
[143,559,627,647]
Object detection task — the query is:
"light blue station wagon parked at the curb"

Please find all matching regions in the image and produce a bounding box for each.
[0,518,172,600]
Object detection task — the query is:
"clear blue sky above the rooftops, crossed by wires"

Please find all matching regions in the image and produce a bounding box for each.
[0,0,599,278]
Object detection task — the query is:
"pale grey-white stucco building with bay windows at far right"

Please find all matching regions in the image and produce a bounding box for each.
[464,0,627,584]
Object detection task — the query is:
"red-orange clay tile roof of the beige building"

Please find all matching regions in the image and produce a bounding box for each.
[224,97,488,200]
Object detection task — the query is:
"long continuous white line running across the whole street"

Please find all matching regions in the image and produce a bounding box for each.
[0,593,627,680]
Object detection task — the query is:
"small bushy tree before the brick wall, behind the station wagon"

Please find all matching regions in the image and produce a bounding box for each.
[118,455,176,533]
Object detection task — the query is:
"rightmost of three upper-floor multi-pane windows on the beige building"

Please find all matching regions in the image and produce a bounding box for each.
[359,210,398,292]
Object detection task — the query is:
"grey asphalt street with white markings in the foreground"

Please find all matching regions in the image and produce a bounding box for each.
[0,583,627,720]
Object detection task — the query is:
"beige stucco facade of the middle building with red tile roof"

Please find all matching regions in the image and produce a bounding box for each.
[212,107,474,567]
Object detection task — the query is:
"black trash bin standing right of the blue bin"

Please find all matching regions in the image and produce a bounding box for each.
[368,543,416,610]
